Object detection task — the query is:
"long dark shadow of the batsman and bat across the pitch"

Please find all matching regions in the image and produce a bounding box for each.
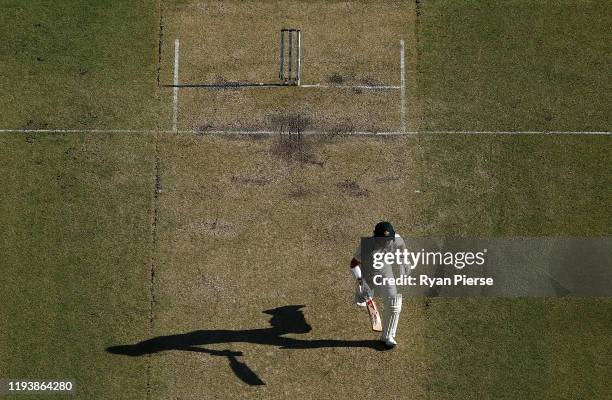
[106,305,385,385]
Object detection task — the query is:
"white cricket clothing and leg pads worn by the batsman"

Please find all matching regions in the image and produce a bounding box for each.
[353,233,411,340]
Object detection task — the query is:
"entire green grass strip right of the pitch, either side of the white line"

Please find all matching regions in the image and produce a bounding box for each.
[417,1,612,399]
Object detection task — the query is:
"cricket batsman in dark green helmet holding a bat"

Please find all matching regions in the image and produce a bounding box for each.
[351,221,407,349]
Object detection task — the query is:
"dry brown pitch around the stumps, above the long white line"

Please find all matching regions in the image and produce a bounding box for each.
[161,1,416,132]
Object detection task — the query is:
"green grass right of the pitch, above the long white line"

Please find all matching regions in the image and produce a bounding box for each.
[417,0,612,131]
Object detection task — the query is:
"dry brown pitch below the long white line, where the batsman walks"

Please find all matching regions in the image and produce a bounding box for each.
[151,137,426,399]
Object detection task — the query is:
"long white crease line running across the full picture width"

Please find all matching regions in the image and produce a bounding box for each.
[0,129,612,136]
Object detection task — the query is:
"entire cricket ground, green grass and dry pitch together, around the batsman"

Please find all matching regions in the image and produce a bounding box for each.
[0,0,612,399]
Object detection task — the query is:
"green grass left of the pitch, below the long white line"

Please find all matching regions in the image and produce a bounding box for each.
[0,134,152,399]
